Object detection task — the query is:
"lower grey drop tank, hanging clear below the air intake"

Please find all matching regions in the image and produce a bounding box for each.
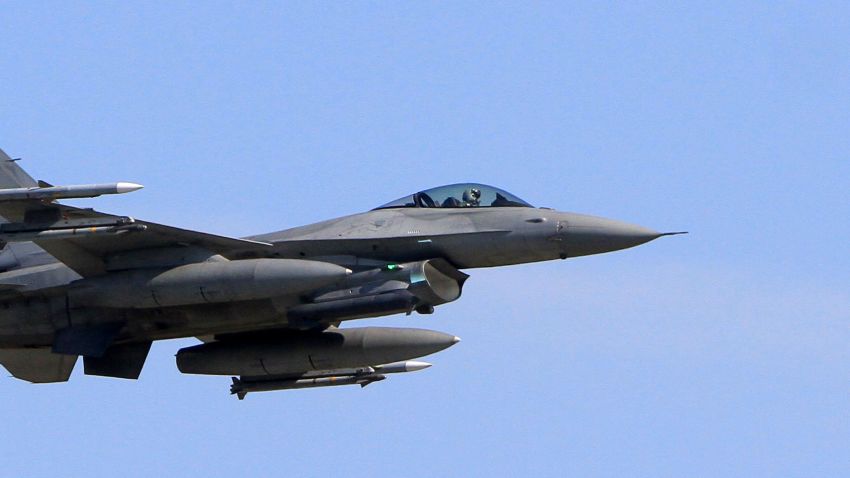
[177,327,460,379]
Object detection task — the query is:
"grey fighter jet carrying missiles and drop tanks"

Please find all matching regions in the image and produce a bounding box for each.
[0,151,675,399]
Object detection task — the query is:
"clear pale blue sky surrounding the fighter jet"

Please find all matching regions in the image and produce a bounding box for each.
[0,1,850,477]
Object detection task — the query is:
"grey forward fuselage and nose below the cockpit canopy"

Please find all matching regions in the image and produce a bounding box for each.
[250,207,661,269]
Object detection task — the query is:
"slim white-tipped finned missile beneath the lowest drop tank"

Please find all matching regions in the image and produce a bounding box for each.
[230,360,431,400]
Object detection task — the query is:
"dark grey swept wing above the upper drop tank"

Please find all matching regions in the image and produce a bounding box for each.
[0,150,271,277]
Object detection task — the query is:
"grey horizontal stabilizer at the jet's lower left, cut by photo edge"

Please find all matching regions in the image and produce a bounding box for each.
[0,348,77,383]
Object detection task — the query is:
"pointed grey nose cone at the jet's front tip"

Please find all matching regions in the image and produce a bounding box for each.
[566,214,664,257]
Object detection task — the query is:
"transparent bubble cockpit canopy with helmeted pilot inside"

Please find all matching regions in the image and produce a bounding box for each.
[376,183,534,209]
